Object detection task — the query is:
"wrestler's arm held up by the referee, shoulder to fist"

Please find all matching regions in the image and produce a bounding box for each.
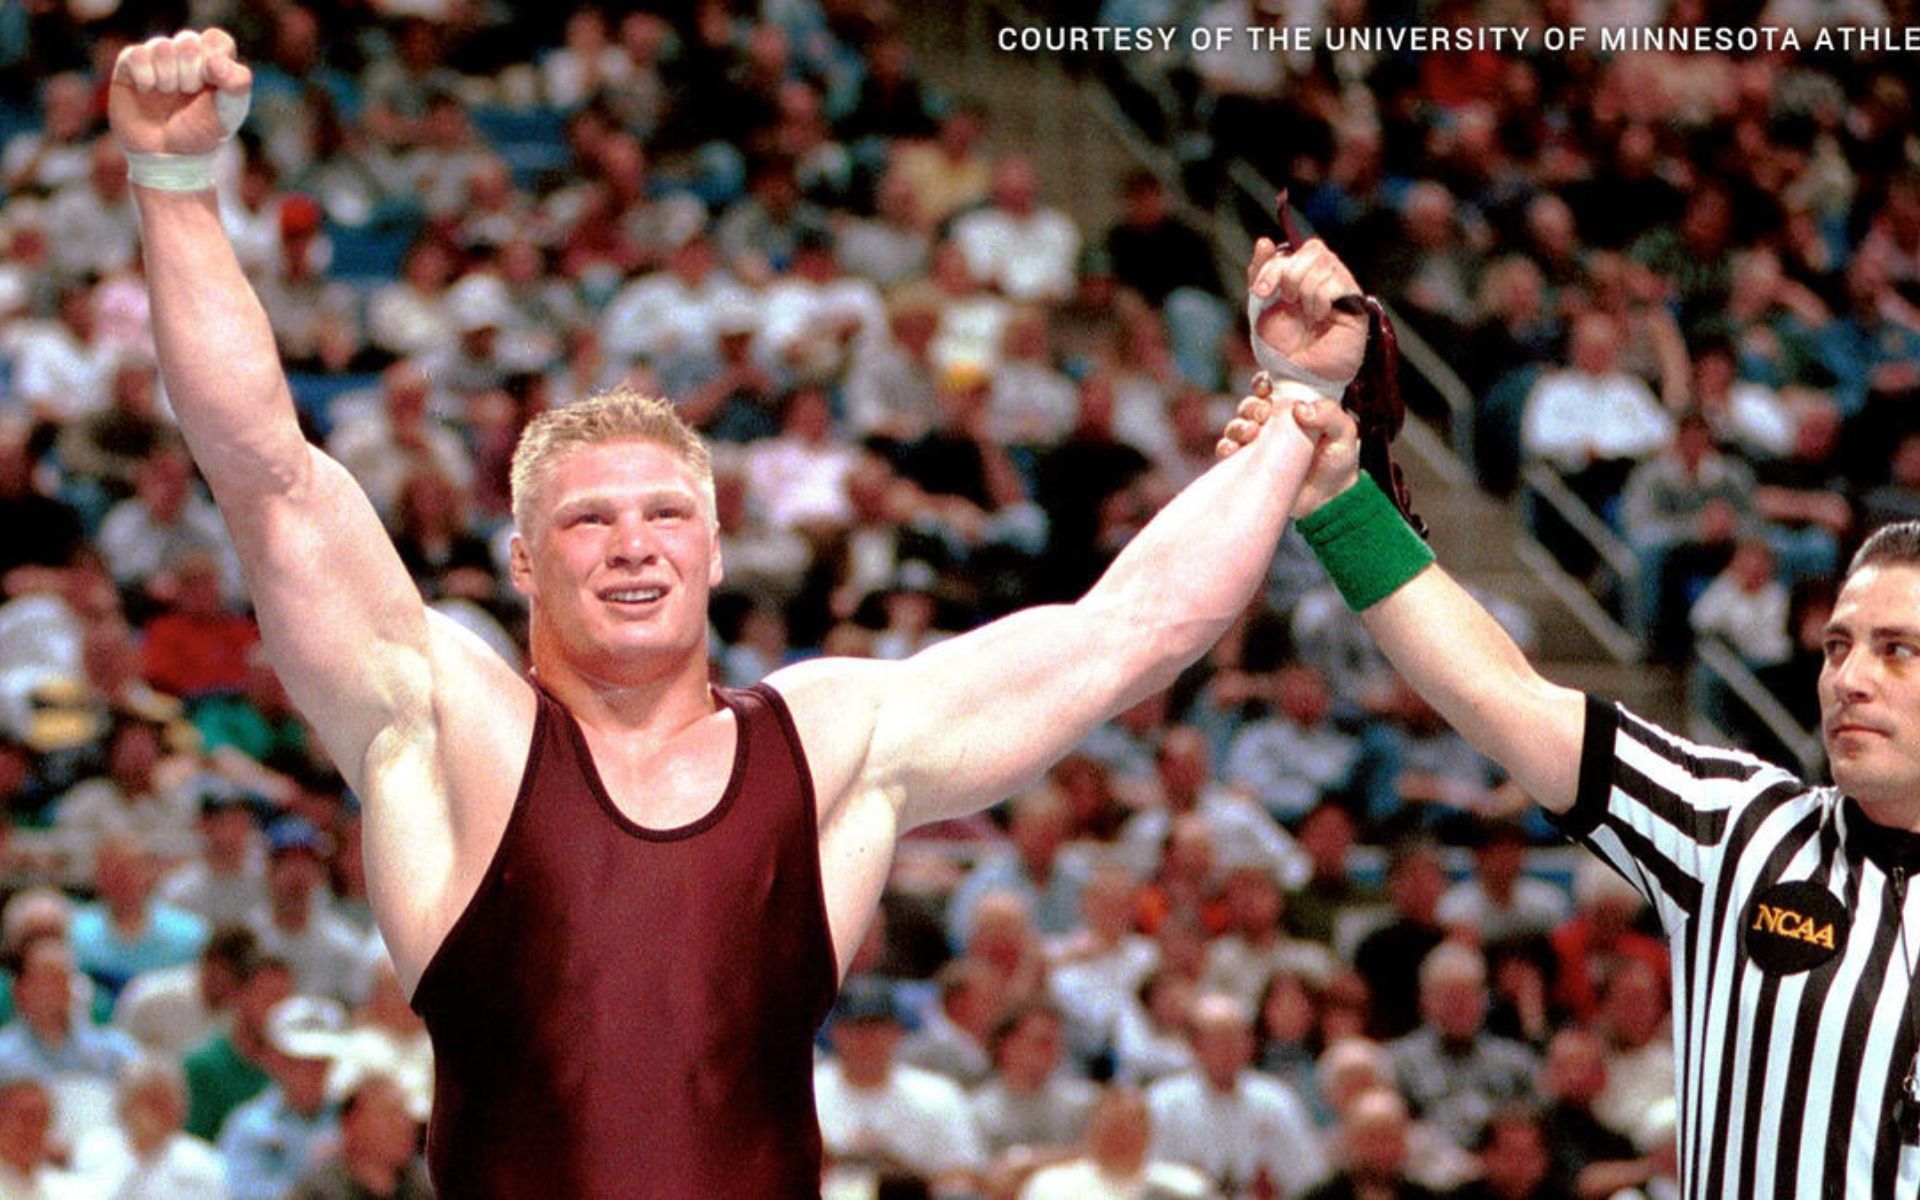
[772,242,1367,826]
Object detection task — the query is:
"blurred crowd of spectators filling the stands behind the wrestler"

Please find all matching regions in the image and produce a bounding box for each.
[0,0,1920,1198]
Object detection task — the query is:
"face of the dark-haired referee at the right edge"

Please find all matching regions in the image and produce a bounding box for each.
[1820,563,1920,829]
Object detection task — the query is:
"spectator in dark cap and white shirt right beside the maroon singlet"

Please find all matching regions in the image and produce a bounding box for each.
[814,977,985,1181]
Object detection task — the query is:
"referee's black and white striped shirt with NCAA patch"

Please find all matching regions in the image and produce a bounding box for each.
[1559,699,1920,1200]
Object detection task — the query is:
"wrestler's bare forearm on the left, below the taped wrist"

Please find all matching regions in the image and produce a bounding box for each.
[134,188,307,497]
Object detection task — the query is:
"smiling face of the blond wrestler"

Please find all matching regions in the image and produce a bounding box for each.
[513,442,720,680]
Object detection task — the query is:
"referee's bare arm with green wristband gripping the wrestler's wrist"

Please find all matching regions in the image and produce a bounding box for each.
[1221,364,1586,812]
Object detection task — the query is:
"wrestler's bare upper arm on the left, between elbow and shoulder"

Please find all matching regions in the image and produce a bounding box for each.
[221,447,432,787]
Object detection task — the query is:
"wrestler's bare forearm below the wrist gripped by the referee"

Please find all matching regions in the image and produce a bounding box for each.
[1079,405,1313,699]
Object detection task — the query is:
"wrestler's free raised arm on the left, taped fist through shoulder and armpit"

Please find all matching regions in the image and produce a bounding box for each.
[109,39,518,979]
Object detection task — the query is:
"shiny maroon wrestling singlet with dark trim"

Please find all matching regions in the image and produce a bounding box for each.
[413,685,835,1200]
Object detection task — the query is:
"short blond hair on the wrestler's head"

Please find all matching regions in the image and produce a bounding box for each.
[507,390,714,536]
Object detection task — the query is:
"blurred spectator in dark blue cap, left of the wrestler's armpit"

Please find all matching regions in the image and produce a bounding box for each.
[252,816,367,1000]
